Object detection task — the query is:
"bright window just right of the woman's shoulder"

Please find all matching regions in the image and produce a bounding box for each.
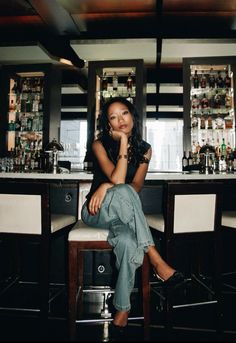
[146,119,183,172]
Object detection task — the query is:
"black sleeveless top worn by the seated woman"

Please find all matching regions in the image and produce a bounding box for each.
[87,140,151,201]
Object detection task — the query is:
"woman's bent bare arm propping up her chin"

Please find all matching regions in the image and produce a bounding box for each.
[92,131,128,185]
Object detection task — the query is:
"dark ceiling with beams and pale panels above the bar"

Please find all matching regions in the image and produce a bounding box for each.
[0,0,236,73]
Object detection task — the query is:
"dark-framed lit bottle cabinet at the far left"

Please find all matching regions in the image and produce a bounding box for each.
[0,64,61,159]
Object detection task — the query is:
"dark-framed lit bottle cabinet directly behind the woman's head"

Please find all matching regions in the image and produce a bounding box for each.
[85,60,146,169]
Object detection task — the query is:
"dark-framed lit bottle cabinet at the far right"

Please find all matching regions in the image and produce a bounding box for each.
[183,57,236,153]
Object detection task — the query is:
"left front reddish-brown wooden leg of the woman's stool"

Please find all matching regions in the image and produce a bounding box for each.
[68,242,78,341]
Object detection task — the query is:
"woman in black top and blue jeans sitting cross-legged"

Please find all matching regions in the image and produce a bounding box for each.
[82,97,183,329]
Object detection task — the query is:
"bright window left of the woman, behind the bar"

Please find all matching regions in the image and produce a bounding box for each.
[59,119,87,171]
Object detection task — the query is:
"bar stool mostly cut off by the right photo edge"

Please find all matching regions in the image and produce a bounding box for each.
[221,211,236,294]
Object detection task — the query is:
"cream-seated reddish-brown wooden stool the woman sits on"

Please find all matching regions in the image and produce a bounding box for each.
[68,220,150,341]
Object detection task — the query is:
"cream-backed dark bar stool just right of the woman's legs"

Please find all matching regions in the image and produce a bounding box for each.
[146,181,222,330]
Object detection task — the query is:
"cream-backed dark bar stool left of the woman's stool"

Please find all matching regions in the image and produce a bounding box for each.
[0,180,77,325]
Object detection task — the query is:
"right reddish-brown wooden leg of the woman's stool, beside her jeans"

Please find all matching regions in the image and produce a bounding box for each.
[142,254,150,341]
